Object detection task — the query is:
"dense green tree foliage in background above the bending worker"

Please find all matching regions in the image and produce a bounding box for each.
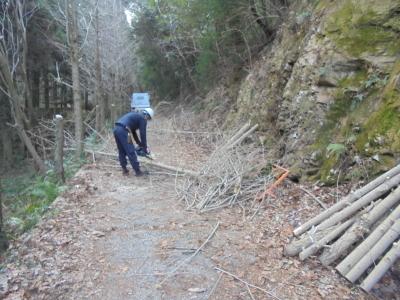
[130,0,288,97]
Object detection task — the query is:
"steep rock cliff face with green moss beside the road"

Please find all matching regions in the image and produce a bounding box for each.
[216,0,400,183]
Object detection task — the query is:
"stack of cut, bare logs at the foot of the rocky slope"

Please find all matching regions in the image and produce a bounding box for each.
[284,165,400,292]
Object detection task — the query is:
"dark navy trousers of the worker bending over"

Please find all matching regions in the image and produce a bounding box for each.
[113,125,140,172]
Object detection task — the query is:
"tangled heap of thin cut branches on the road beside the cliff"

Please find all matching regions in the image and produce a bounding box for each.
[177,123,273,212]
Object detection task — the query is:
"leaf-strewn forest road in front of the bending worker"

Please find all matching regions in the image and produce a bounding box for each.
[1,116,384,299]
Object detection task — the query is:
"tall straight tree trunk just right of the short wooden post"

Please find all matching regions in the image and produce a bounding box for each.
[66,0,83,158]
